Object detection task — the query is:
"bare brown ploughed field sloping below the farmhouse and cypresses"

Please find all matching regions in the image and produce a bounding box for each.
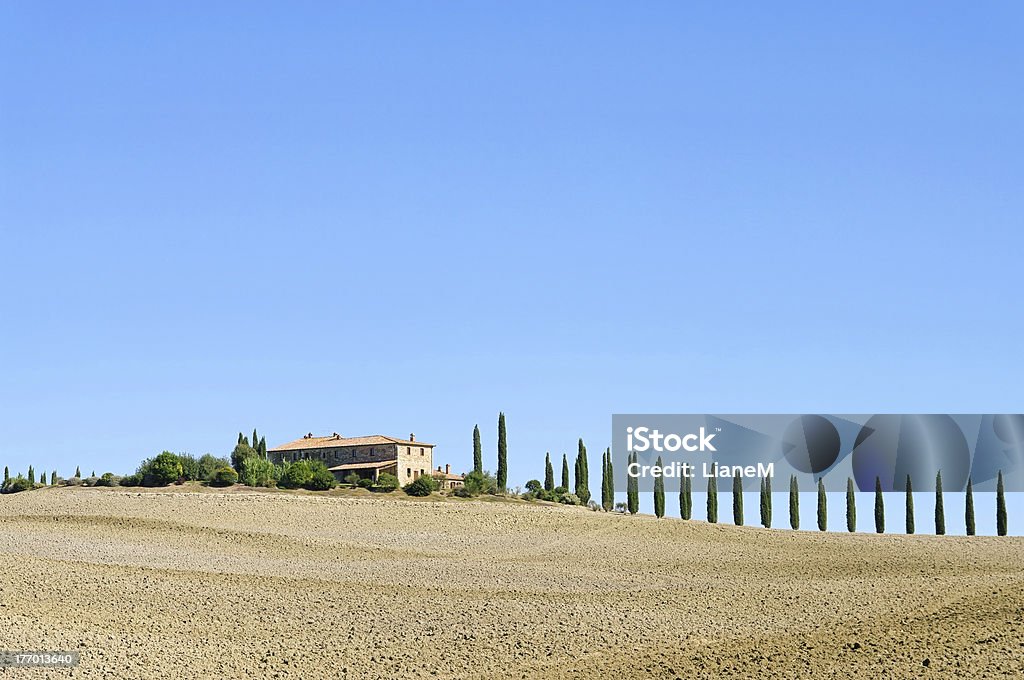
[0,487,1024,678]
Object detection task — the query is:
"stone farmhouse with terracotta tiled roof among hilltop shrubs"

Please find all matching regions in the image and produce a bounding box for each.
[267,432,462,490]
